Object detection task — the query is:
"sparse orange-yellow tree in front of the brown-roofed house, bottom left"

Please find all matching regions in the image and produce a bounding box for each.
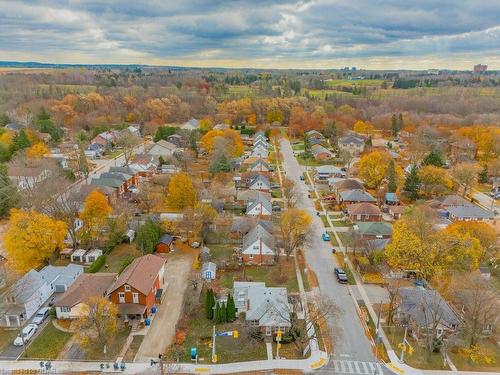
[76,297,118,351]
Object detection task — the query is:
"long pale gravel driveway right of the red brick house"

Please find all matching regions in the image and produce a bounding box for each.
[136,251,195,361]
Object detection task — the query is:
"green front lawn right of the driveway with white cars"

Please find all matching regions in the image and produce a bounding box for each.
[24,322,73,359]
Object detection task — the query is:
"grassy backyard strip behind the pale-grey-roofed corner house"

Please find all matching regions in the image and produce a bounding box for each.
[220,258,299,293]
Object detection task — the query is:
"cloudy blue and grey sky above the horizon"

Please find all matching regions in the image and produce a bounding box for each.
[0,0,500,70]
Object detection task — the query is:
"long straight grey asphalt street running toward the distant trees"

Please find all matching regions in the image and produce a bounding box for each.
[281,139,377,362]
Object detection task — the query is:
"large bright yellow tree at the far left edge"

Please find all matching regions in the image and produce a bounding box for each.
[4,209,67,272]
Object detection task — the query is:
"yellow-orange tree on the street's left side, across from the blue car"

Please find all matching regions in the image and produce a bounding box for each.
[279,208,312,257]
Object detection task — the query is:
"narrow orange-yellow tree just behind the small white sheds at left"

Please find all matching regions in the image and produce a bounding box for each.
[80,190,113,246]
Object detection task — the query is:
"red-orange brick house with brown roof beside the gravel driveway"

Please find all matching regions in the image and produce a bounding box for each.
[108,254,166,318]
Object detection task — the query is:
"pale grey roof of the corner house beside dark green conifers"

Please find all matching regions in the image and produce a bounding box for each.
[246,286,291,327]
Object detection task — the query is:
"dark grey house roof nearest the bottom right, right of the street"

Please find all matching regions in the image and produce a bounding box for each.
[399,288,461,327]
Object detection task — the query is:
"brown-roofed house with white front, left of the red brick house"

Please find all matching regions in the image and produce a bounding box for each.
[54,272,117,319]
